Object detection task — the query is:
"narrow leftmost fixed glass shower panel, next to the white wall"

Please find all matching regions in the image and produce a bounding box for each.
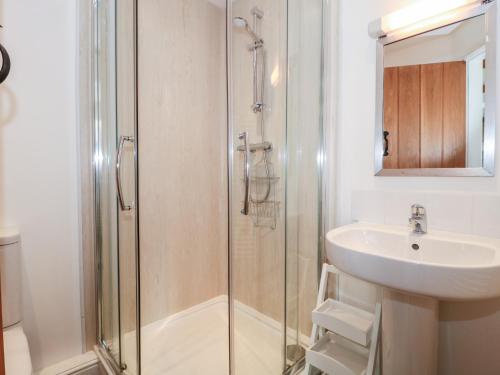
[94,1,120,363]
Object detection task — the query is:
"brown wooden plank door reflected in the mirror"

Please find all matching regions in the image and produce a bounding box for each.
[384,61,467,169]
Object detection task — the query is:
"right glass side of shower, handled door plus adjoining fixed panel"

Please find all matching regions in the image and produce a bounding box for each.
[228,0,323,375]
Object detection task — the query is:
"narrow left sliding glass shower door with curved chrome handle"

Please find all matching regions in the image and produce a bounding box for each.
[115,0,139,375]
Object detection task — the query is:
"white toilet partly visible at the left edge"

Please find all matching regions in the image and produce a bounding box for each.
[0,228,32,375]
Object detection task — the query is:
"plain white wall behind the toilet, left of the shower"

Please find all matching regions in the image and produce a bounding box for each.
[0,0,82,368]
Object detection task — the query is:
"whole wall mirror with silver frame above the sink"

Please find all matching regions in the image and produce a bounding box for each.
[375,4,496,176]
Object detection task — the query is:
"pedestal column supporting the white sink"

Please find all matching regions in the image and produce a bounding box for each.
[382,288,439,375]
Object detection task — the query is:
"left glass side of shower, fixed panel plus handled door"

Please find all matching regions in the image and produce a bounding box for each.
[93,0,138,375]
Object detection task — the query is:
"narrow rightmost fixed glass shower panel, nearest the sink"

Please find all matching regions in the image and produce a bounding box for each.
[286,0,323,365]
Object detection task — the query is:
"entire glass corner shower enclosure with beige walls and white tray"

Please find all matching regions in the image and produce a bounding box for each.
[93,0,326,375]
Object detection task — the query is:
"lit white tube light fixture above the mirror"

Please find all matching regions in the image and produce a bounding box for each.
[368,0,484,38]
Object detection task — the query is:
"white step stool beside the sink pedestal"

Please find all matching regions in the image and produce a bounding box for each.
[304,264,382,375]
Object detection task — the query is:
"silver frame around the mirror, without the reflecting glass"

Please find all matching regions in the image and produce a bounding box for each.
[374,1,498,177]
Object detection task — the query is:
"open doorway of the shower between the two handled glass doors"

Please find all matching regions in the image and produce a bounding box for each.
[138,0,229,375]
